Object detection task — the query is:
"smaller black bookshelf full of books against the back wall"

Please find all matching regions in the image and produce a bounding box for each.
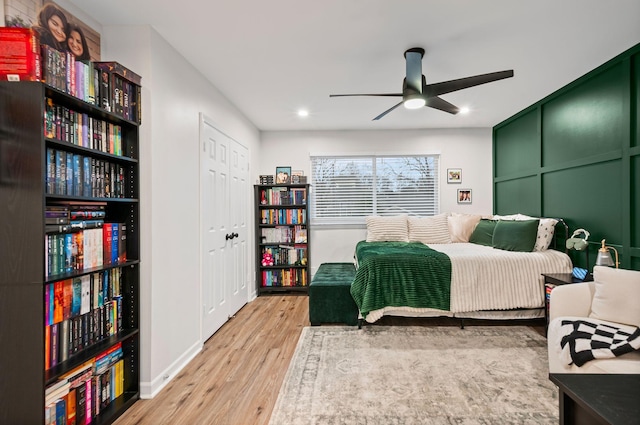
[254,184,311,295]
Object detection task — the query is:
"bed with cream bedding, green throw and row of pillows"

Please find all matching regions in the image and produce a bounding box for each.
[351,214,572,323]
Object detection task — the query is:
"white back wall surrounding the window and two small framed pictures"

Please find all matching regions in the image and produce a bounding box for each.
[258,128,493,273]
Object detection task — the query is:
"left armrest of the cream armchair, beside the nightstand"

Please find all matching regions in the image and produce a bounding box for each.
[549,282,596,321]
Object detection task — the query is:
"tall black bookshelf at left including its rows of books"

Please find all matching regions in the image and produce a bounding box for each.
[0,74,140,424]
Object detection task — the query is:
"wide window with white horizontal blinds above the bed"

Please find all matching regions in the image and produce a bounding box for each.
[311,155,439,224]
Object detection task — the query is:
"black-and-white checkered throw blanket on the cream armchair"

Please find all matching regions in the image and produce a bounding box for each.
[560,320,640,366]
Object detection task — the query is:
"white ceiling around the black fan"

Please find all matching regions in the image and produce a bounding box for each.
[70,0,640,130]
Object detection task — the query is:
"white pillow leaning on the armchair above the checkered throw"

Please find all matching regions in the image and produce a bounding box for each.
[589,266,640,326]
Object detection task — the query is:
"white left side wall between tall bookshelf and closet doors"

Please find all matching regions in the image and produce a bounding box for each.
[102,26,259,398]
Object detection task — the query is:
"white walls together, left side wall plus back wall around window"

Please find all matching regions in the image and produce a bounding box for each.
[50,0,492,398]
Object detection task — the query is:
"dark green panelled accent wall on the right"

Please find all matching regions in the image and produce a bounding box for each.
[493,44,640,270]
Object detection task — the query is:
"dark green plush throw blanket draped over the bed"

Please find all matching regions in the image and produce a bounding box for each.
[351,241,451,317]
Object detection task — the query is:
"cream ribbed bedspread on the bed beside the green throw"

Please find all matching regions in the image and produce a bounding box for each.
[366,243,572,323]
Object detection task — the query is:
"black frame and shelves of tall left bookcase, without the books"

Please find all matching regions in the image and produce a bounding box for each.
[0,82,140,424]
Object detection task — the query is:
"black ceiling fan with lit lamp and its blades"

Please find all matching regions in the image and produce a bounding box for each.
[329,47,513,121]
